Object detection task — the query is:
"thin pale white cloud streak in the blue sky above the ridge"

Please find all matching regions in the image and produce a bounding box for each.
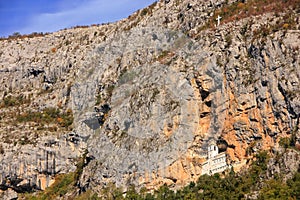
[20,0,154,33]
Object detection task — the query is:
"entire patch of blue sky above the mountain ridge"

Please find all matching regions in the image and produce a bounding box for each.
[0,0,156,37]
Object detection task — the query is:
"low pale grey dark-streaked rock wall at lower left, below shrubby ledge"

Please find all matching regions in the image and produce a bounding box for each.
[0,133,85,192]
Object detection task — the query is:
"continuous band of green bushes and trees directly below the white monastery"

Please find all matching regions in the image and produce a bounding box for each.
[65,151,300,200]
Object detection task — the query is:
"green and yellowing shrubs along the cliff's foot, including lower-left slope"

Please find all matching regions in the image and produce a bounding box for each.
[22,151,300,200]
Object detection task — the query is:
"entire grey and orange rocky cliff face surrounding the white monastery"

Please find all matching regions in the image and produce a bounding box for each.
[0,0,300,197]
